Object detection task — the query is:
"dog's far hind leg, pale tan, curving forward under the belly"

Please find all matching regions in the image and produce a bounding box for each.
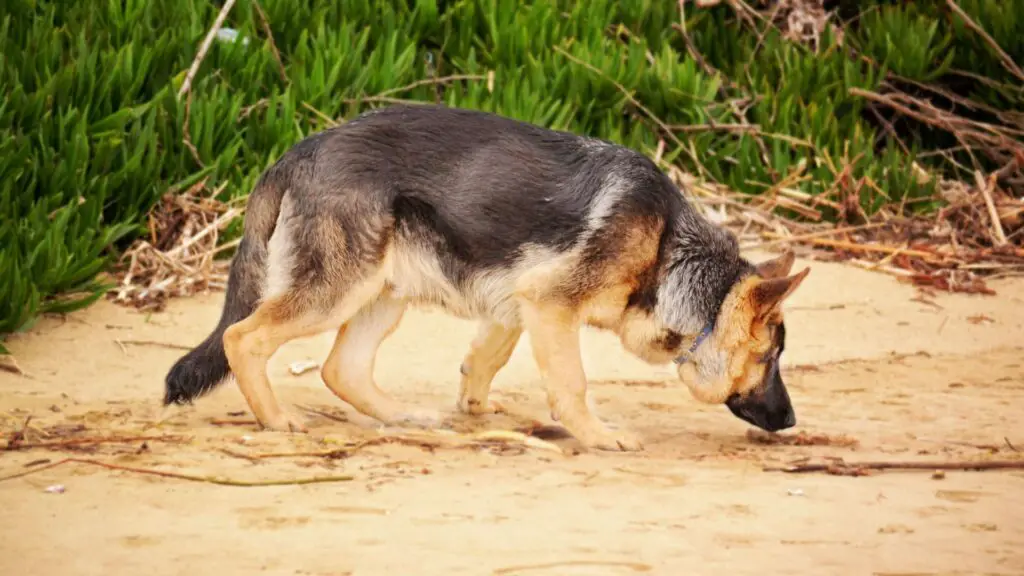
[321,296,442,427]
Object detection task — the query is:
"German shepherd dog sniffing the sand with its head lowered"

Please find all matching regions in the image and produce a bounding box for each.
[164,105,810,450]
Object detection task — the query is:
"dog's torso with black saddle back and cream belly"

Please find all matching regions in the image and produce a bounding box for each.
[270,106,688,322]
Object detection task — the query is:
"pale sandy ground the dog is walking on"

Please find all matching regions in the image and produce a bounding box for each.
[0,252,1024,576]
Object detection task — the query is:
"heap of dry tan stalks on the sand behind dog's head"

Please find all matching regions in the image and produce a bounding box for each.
[662,163,1024,295]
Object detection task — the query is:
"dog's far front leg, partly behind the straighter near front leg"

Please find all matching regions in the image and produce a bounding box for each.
[458,320,522,414]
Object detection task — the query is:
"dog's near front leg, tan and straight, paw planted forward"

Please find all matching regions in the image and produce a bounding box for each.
[520,300,642,451]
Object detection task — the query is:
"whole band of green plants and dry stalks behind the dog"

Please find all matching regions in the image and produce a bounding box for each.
[0,0,1024,344]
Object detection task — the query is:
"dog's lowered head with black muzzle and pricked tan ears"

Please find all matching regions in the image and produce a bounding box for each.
[678,252,810,431]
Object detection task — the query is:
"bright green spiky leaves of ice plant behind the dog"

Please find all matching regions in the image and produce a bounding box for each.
[0,0,1024,337]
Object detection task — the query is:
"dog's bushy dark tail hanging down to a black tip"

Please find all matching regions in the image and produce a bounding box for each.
[164,170,286,406]
